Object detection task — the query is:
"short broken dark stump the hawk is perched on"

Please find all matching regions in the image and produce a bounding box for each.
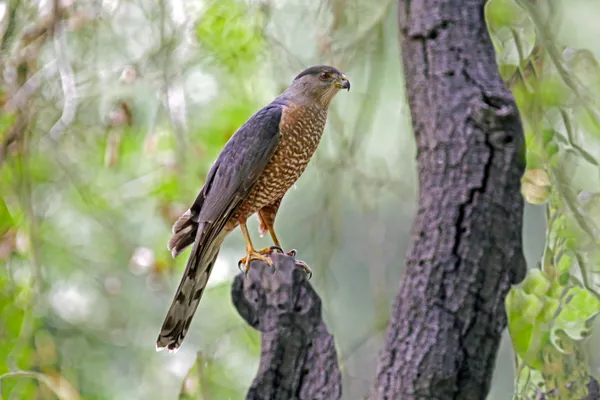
[231,253,342,400]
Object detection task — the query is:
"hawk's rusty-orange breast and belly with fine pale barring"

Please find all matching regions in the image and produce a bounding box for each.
[234,105,327,222]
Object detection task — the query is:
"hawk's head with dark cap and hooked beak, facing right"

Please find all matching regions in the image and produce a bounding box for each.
[288,65,350,107]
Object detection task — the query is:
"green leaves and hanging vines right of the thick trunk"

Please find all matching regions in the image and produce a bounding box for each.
[486,0,600,399]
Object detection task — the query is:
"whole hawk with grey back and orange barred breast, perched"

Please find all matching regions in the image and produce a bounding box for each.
[156,65,350,351]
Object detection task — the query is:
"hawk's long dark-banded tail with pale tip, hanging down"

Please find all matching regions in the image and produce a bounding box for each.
[156,222,224,351]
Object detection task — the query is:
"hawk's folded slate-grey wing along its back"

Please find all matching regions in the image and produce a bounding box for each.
[168,103,283,257]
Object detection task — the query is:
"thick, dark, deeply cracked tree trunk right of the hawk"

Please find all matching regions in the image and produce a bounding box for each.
[372,0,525,400]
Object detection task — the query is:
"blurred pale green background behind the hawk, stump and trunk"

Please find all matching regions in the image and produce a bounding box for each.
[0,0,600,400]
